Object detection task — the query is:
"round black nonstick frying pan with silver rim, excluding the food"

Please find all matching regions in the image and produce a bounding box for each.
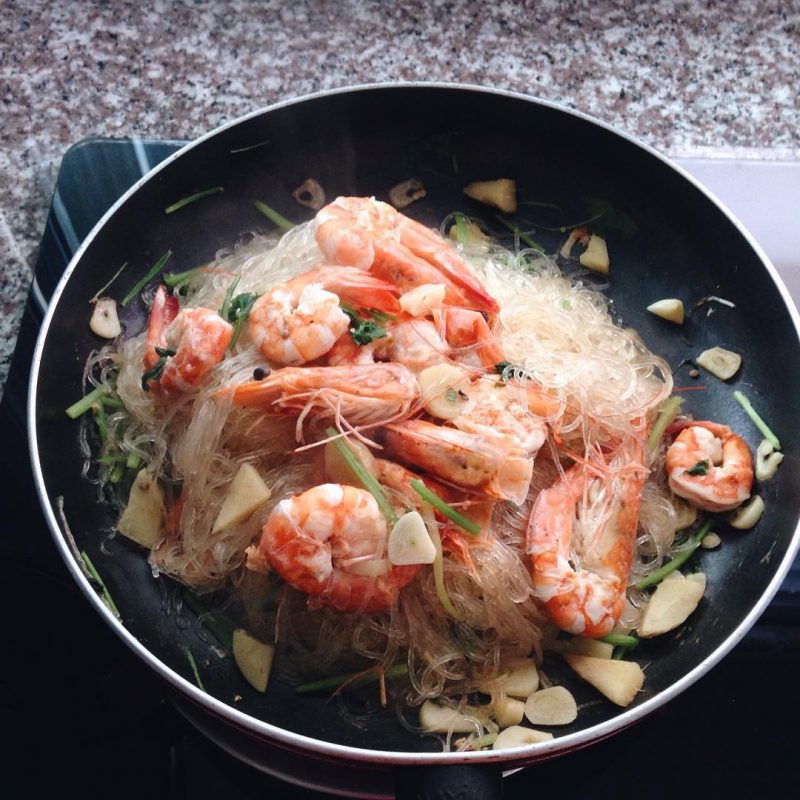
[29,84,800,797]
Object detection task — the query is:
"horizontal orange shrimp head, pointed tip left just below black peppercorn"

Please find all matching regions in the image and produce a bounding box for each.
[227,363,419,432]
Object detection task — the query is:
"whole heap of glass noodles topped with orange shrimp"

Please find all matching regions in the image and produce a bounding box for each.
[79,198,756,742]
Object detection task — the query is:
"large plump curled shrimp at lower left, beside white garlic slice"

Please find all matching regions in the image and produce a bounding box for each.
[258,483,419,613]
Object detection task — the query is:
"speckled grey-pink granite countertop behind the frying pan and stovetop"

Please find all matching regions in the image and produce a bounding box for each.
[0,0,800,394]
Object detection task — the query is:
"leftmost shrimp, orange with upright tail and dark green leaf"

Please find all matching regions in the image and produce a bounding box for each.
[144,286,233,394]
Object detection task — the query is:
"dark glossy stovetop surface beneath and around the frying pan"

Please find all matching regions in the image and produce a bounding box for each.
[0,140,800,800]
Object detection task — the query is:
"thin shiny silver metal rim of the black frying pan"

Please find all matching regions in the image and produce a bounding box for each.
[28,81,800,766]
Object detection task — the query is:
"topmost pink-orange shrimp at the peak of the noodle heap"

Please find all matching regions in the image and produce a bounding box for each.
[316,197,499,314]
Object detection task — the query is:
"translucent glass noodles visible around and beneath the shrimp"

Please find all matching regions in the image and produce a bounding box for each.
[87,216,692,740]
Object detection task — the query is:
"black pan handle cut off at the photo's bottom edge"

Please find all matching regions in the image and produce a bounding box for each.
[396,764,504,800]
